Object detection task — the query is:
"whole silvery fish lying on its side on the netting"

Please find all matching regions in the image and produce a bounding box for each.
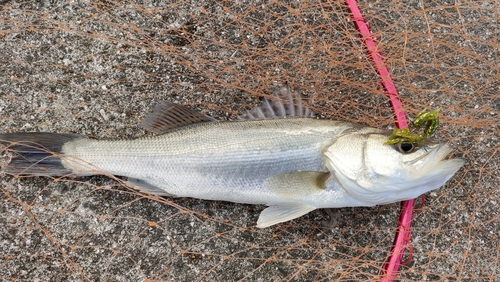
[0,84,465,228]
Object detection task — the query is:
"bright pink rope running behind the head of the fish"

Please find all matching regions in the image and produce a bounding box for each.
[345,0,413,281]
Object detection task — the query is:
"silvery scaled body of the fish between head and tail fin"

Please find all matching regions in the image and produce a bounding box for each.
[62,119,351,205]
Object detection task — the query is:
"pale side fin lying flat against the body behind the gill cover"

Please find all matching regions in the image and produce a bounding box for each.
[266,171,330,199]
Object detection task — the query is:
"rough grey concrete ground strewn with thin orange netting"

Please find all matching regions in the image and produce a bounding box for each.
[0,0,500,281]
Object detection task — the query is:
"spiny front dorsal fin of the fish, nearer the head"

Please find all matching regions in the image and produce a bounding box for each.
[238,83,314,120]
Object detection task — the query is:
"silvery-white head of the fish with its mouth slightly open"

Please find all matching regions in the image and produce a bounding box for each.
[325,131,465,206]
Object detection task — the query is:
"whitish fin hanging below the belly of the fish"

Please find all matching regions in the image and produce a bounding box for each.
[257,204,316,228]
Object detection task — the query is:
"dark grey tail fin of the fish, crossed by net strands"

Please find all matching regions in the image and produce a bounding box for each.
[0,132,86,176]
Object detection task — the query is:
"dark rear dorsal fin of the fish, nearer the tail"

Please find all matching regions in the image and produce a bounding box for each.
[140,101,217,134]
